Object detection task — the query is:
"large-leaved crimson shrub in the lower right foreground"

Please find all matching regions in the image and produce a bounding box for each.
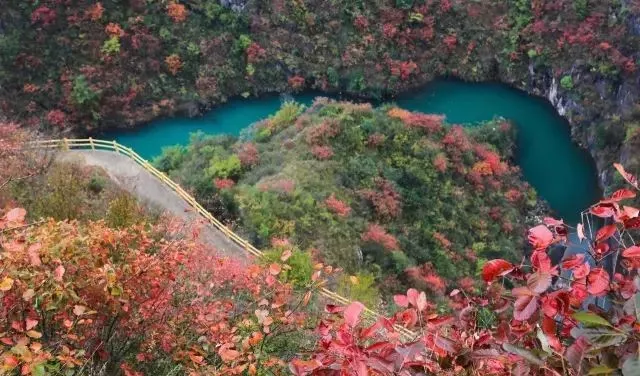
[290,165,640,376]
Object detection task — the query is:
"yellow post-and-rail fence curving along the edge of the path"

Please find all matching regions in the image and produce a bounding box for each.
[31,138,417,340]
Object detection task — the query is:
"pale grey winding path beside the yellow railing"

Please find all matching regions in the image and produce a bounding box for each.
[56,150,250,260]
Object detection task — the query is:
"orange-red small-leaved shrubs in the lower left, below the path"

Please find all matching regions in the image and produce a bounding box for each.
[0,208,317,375]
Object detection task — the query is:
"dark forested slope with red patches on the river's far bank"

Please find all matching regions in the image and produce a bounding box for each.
[0,0,640,179]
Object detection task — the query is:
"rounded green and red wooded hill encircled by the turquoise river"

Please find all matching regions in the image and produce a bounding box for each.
[156,99,537,294]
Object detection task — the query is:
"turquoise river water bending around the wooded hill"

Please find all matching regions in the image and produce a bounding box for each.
[107,79,600,223]
